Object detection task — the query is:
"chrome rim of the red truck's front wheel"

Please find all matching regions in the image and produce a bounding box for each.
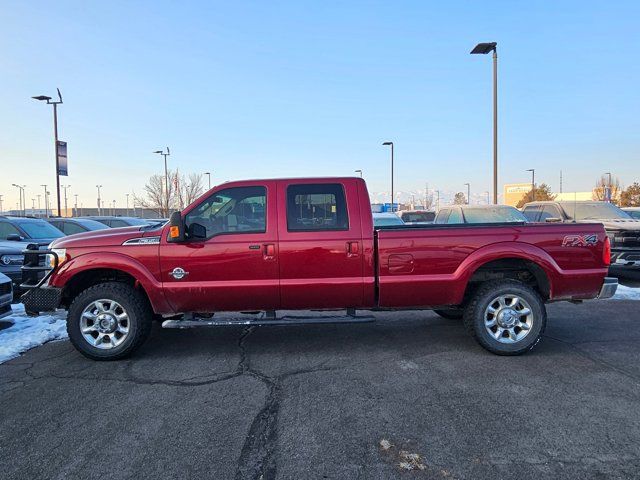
[80,299,129,350]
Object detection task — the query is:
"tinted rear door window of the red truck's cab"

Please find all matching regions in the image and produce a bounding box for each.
[287,183,349,232]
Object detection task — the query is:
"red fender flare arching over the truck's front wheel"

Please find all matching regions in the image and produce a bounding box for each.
[50,252,173,313]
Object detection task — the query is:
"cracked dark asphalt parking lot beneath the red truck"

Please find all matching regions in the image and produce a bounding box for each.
[0,301,640,480]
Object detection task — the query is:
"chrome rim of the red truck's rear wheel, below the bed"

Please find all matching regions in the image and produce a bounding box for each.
[484,295,534,343]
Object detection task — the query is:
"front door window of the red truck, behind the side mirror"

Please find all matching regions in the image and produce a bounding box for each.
[184,186,267,238]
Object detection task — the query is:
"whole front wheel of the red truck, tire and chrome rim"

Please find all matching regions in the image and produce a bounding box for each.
[67,282,153,360]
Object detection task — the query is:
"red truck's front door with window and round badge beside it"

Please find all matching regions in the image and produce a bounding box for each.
[160,182,280,312]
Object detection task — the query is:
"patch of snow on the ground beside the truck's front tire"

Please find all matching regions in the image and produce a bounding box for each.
[0,303,67,363]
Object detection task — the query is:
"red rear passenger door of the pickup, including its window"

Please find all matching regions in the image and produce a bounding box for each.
[278,179,362,309]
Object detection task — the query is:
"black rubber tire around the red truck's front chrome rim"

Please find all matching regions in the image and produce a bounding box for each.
[67,282,153,360]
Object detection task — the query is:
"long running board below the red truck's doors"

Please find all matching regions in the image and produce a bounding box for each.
[162,315,376,328]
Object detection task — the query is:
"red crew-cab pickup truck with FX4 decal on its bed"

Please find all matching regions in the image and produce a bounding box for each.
[23,178,617,360]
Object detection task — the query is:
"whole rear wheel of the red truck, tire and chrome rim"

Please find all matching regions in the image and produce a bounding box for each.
[464,280,547,355]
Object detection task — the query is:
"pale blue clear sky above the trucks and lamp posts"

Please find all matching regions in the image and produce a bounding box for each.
[0,1,640,207]
